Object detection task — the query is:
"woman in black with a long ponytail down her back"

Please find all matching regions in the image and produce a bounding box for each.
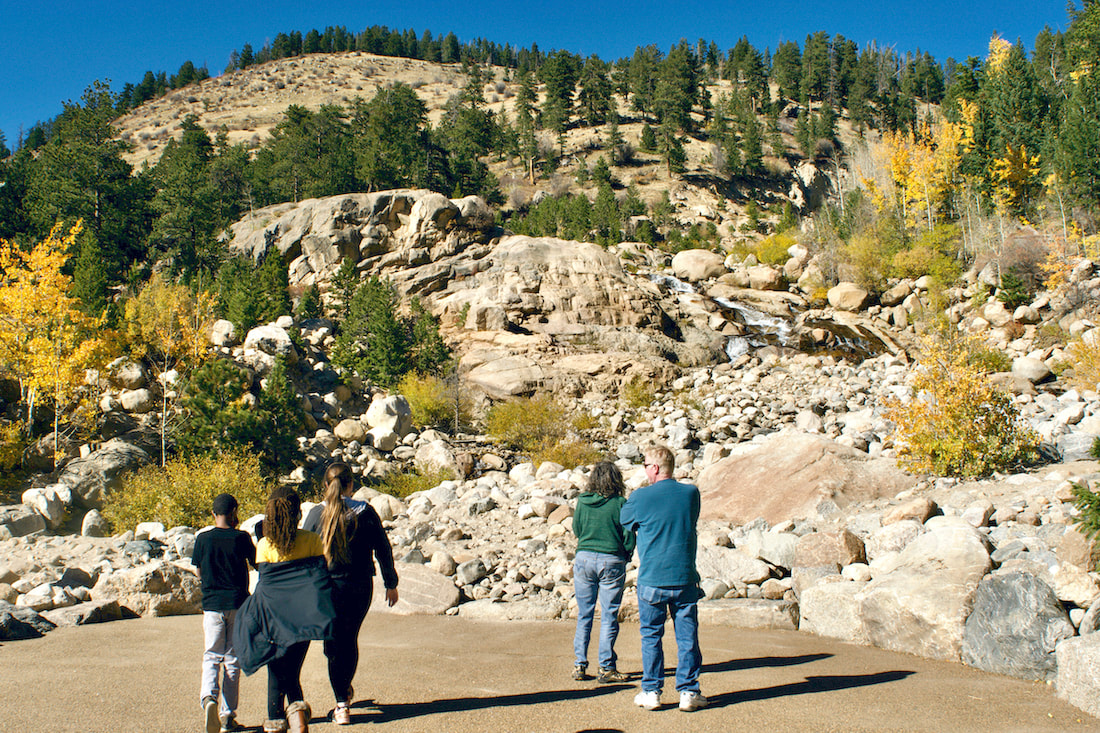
[303,462,397,725]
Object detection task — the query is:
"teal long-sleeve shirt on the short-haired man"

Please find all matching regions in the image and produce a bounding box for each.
[619,479,700,588]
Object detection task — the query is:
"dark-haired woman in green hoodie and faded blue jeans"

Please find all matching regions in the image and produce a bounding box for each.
[573,461,635,683]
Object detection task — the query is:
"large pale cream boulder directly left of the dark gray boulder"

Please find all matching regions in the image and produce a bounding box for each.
[857,517,992,661]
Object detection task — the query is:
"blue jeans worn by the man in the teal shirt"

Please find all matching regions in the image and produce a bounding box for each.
[638,586,703,692]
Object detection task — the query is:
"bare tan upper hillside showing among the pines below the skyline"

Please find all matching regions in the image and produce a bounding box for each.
[109,52,859,242]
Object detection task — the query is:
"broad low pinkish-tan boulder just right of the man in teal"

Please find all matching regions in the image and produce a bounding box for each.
[697,434,915,525]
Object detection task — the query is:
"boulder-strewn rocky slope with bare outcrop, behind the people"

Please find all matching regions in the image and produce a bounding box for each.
[0,192,1100,714]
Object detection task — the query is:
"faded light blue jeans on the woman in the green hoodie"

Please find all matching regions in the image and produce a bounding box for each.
[573,550,626,669]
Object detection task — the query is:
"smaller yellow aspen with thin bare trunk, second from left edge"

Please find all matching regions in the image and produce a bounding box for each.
[123,274,215,466]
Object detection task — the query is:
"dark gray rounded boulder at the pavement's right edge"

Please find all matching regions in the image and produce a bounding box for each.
[963,572,1076,680]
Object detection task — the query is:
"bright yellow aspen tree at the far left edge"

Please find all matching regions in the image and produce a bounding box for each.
[0,221,109,461]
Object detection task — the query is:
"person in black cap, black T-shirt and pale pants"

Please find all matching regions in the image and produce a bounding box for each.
[191,494,256,733]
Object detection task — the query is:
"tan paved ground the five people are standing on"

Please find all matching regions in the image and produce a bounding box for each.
[0,614,1100,733]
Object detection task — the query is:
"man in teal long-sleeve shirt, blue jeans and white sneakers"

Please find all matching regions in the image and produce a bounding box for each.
[619,446,707,712]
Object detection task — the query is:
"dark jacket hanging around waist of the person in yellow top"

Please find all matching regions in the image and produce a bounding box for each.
[233,557,336,675]
